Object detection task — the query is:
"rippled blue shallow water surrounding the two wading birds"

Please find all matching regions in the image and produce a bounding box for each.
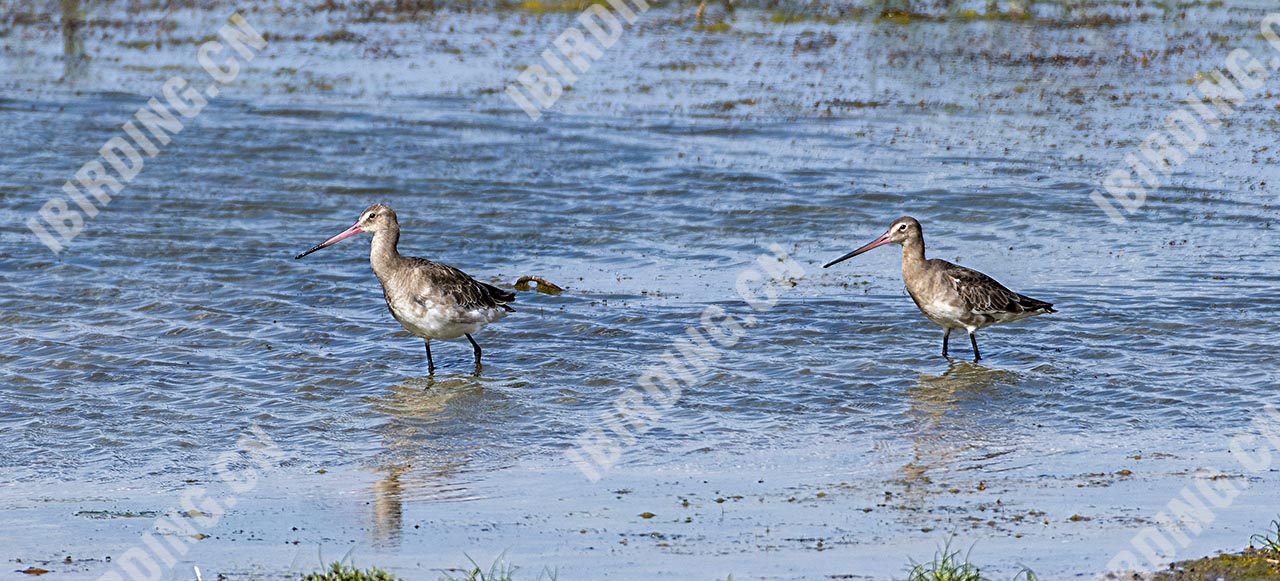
[0,5,1280,578]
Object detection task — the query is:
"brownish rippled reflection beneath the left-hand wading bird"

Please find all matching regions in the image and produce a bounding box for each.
[369,376,499,546]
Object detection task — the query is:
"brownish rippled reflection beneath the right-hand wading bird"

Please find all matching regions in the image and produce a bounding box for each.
[902,361,1020,500]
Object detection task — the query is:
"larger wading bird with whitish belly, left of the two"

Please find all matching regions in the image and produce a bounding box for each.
[294,203,516,374]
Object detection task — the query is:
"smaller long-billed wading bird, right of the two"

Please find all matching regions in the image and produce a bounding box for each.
[823,216,1057,361]
